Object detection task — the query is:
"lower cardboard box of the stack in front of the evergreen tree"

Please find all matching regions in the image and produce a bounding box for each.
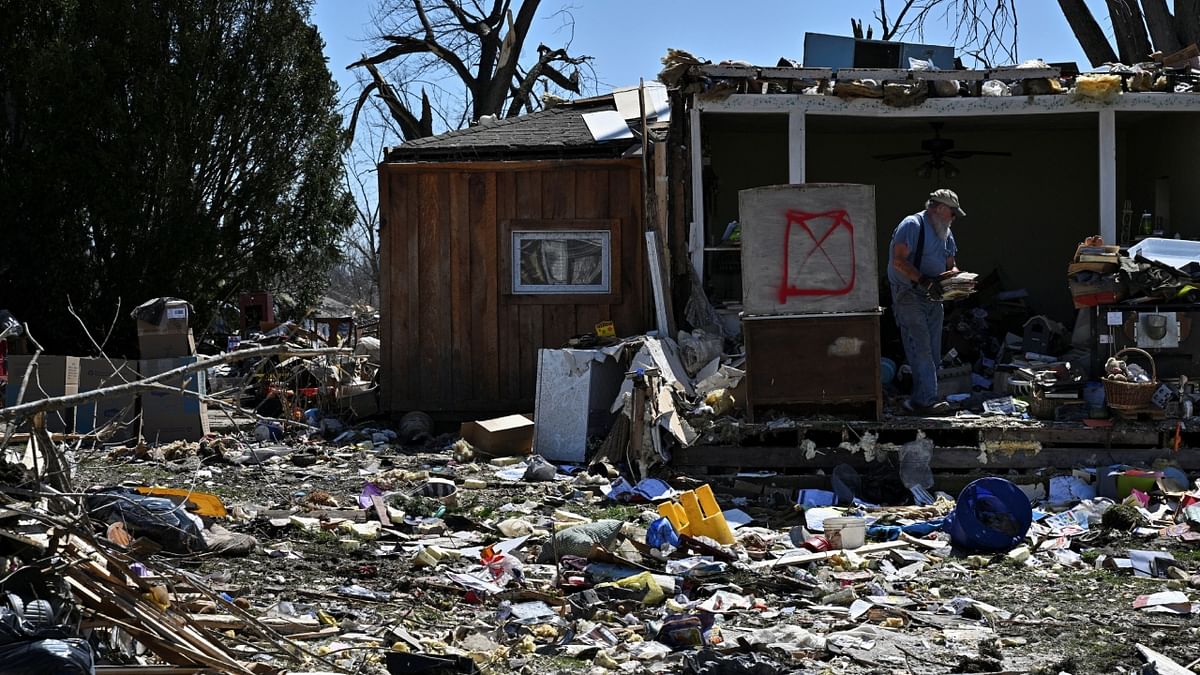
[138,357,209,444]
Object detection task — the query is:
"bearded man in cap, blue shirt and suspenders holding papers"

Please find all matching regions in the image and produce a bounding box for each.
[888,189,966,414]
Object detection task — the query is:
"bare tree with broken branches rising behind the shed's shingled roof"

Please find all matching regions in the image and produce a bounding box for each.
[349,0,590,141]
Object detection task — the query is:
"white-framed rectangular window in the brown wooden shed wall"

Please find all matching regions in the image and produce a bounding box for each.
[512,229,612,294]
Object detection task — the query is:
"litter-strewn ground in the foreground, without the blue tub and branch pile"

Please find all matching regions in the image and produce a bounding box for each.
[0,401,1200,674]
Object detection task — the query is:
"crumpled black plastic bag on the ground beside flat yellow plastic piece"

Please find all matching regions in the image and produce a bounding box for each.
[86,488,208,554]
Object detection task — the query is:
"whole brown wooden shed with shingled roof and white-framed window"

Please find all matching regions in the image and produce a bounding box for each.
[379,97,653,419]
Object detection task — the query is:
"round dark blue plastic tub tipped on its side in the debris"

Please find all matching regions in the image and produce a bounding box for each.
[946,478,1033,551]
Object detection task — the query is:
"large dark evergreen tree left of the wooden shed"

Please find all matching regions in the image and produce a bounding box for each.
[0,0,353,354]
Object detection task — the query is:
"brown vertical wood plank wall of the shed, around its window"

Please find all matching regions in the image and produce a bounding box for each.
[379,160,653,418]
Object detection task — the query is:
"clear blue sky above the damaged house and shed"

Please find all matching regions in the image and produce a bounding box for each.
[313,0,1108,102]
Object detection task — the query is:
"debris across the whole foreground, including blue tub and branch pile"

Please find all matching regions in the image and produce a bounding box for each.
[0,398,1200,674]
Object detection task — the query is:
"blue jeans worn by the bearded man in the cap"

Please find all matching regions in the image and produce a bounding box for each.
[892,286,943,407]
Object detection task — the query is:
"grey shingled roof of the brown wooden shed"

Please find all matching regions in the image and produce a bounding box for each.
[385,96,635,162]
